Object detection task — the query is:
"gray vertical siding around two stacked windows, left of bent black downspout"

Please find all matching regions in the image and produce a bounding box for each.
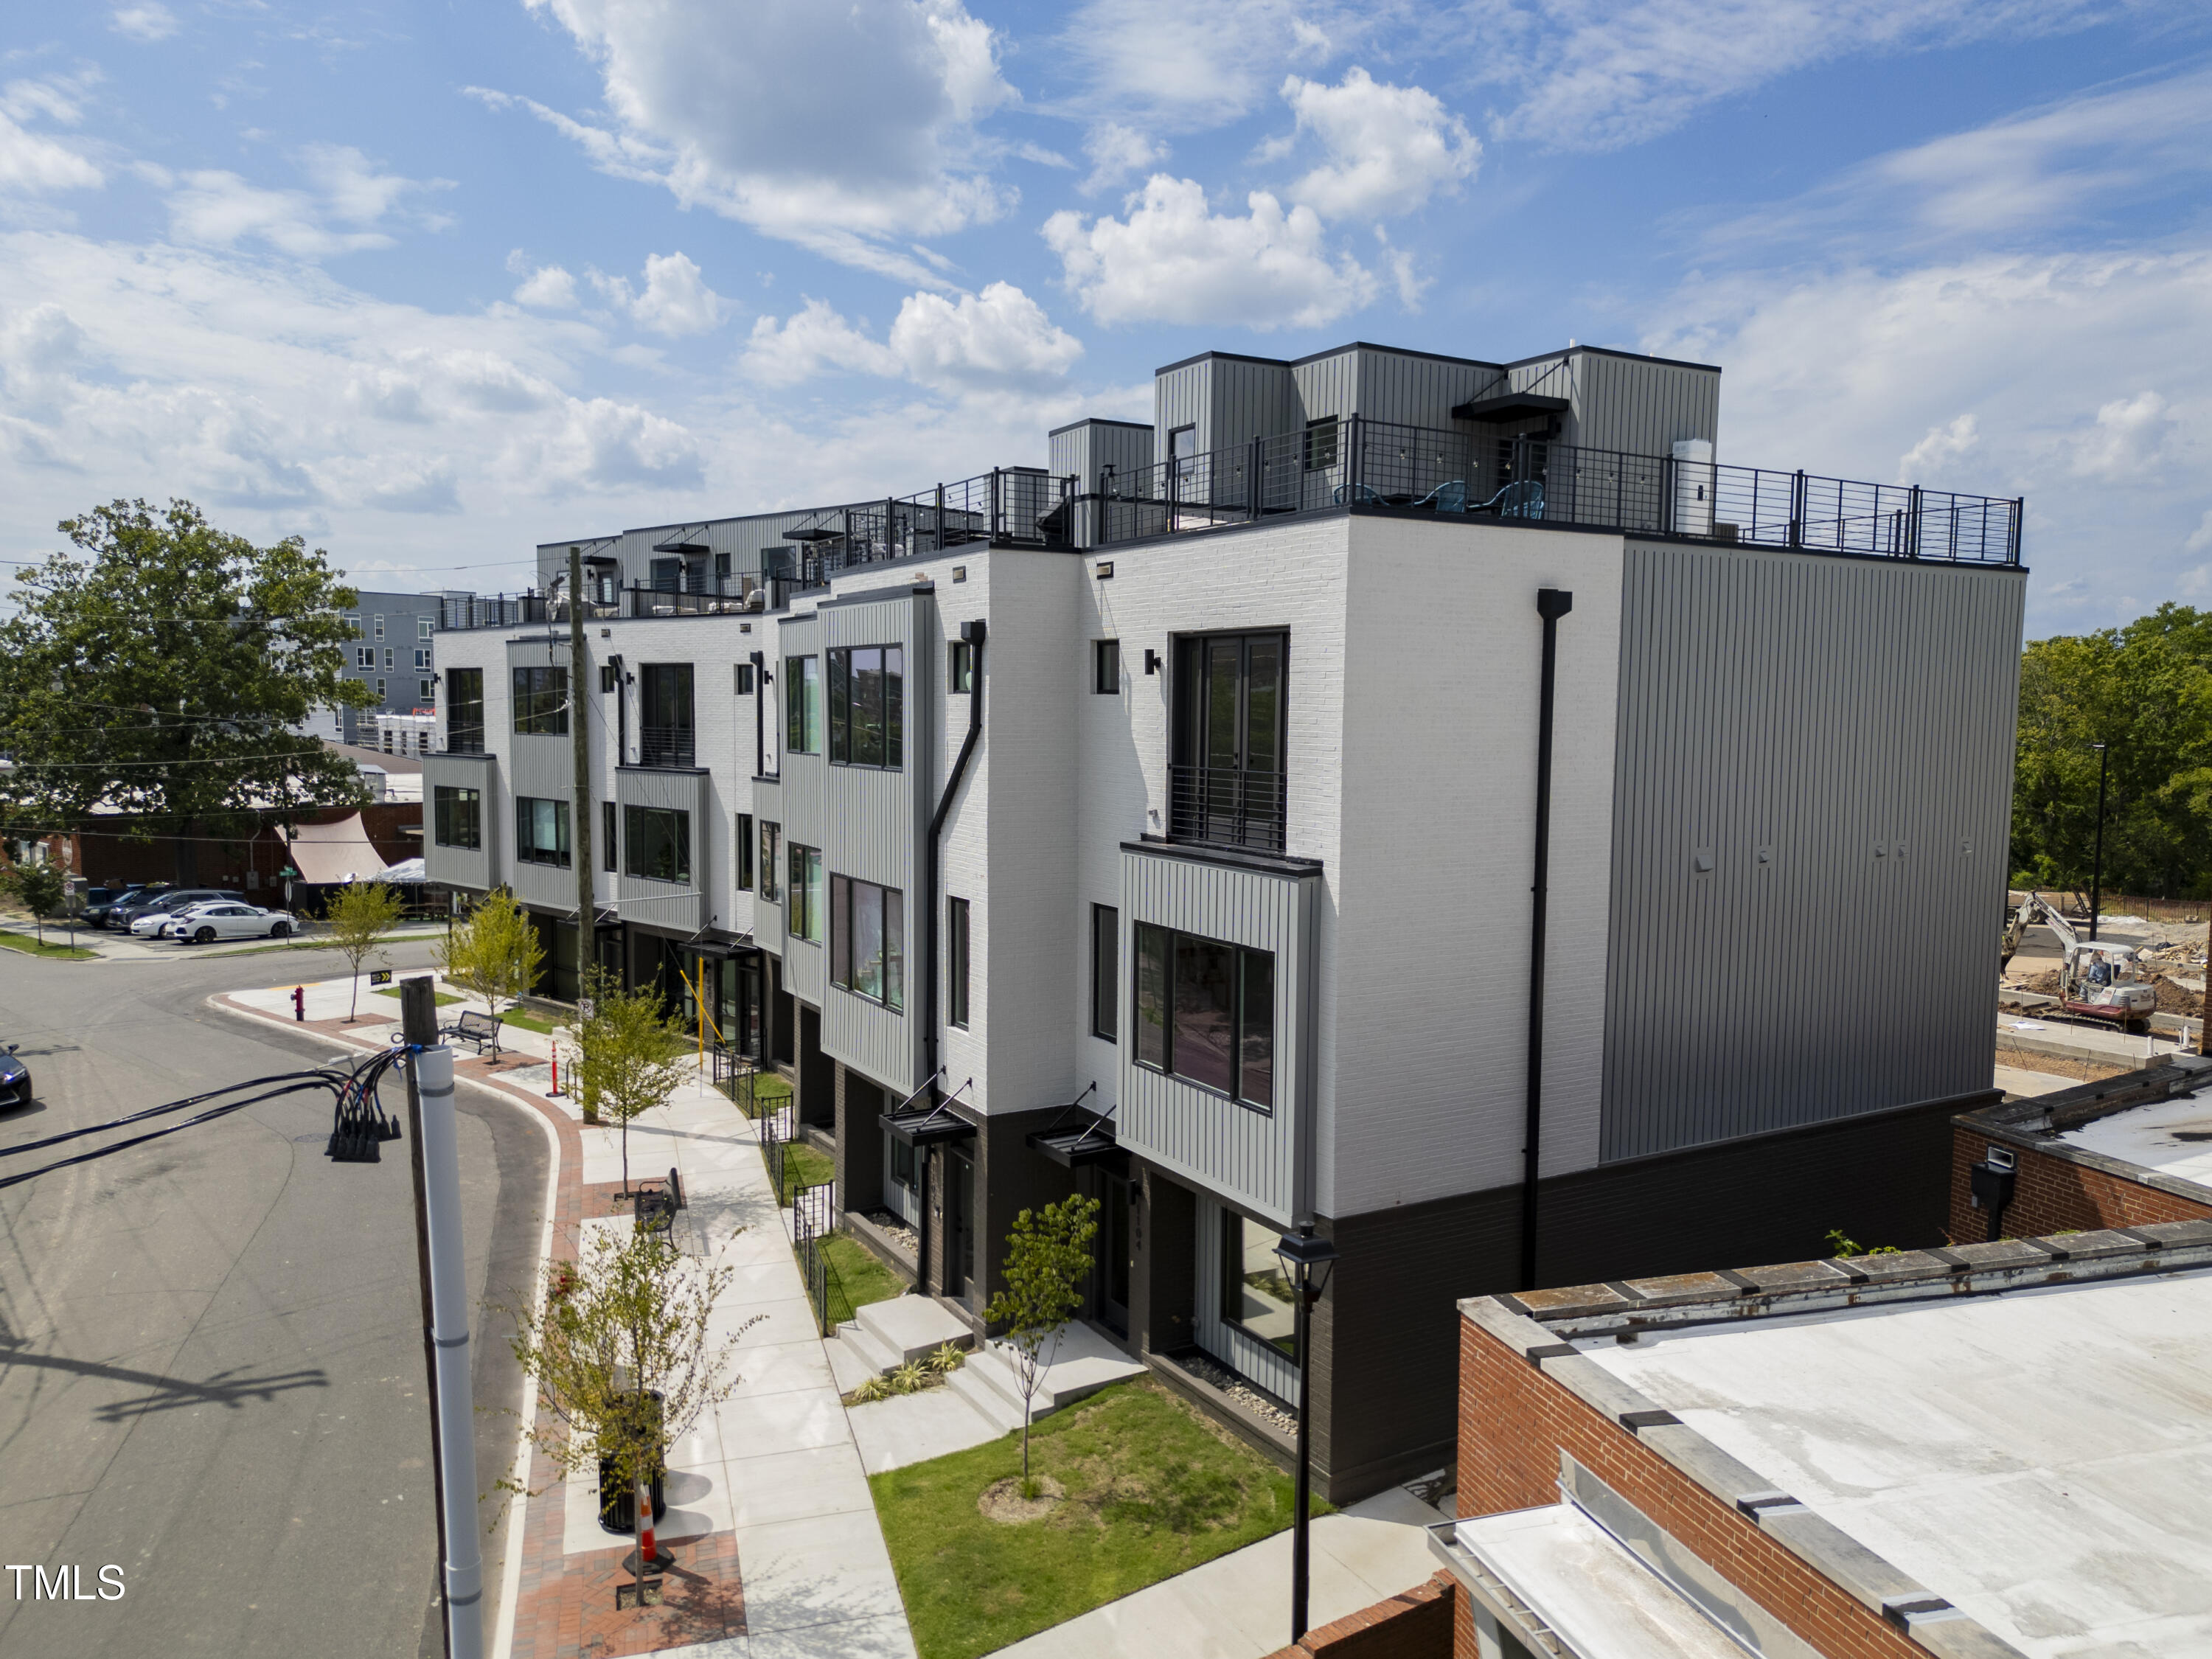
[818,595,945,1093]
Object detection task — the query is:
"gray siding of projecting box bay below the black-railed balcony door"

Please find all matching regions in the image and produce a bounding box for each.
[1115,849,1318,1225]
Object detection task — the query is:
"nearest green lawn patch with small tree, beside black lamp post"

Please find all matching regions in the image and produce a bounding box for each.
[867,1378,1325,1659]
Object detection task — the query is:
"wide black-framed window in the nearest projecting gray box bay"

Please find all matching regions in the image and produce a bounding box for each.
[1135,922,1274,1110]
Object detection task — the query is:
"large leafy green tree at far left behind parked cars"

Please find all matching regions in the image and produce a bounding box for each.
[0,500,367,885]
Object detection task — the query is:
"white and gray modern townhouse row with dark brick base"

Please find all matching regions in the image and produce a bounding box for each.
[425,345,2024,1500]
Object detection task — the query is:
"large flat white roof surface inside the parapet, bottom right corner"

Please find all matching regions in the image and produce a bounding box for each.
[1577,1272,2212,1659]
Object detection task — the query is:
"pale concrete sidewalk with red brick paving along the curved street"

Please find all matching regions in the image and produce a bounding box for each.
[219,980,914,1659]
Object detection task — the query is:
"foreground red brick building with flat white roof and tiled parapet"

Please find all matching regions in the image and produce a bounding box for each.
[1433,1221,2212,1659]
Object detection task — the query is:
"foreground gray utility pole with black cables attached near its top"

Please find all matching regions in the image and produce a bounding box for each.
[400,975,484,1659]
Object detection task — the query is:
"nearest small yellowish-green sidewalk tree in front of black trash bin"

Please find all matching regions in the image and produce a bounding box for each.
[500,1228,757,1575]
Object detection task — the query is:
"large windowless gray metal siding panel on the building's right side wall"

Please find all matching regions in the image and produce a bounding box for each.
[1601,544,2024,1159]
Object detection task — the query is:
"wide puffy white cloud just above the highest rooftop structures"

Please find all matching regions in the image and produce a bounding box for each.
[1044,173,1376,330]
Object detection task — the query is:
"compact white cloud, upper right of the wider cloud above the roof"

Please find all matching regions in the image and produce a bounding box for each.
[1283,66,1482,219]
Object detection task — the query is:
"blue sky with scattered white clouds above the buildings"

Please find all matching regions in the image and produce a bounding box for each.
[0,0,2212,635]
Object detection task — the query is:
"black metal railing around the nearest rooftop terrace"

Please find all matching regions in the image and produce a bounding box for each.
[1079,416,2022,564]
